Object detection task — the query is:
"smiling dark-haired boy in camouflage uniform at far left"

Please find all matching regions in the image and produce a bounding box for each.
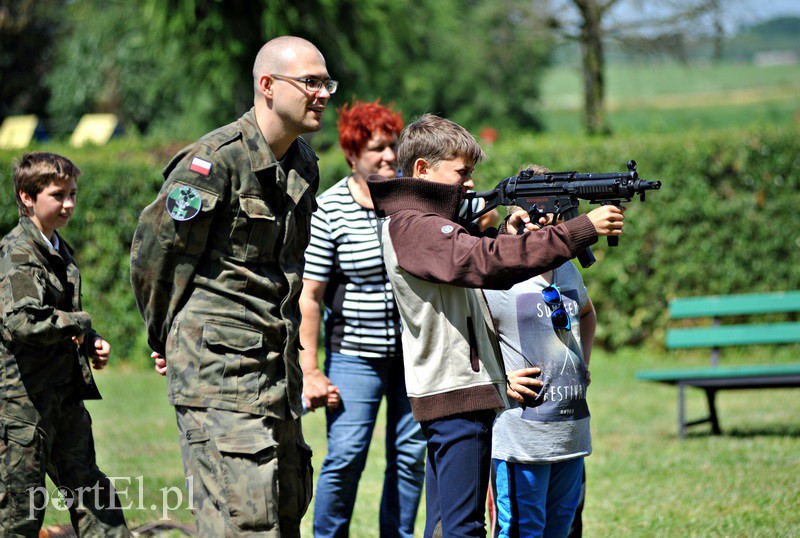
[0,153,130,537]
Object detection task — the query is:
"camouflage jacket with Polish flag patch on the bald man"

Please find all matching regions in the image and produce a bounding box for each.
[131,109,319,419]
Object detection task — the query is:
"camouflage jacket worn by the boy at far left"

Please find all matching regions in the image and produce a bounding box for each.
[0,217,100,399]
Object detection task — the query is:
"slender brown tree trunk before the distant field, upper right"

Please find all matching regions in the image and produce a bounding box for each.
[575,0,610,135]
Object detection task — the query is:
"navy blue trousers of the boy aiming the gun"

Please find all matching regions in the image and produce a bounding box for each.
[422,410,496,538]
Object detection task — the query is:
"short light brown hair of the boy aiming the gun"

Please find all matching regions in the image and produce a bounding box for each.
[397,114,486,177]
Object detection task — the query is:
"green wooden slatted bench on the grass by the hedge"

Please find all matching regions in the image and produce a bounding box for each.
[636,291,800,438]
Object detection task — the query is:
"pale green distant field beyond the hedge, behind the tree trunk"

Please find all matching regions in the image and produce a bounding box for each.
[541,63,800,132]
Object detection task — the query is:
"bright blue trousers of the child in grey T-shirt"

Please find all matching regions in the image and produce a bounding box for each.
[492,458,583,538]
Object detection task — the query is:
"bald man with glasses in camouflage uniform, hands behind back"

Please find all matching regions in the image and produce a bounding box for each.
[131,37,336,537]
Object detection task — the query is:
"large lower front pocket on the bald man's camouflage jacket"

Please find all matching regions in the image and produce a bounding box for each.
[199,321,267,404]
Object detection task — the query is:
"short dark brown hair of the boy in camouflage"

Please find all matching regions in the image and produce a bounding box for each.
[14,151,81,217]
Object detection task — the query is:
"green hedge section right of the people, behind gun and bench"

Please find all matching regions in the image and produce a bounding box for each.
[482,124,800,348]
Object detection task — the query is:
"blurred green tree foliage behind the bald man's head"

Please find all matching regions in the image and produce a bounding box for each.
[4,0,552,139]
